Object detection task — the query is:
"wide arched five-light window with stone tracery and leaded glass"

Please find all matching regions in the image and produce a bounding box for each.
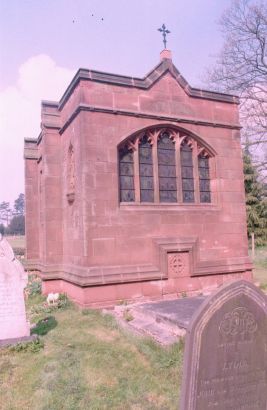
[119,128,214,204]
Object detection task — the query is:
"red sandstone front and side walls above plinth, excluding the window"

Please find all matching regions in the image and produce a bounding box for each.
[26,64,250,290]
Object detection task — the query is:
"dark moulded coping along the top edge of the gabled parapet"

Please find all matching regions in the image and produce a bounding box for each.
[47,58,239,110]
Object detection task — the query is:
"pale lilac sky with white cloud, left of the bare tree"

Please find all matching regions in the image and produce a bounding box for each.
[0,0,231,205]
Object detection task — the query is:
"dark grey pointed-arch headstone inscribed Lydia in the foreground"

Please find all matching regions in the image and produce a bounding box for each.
[180,281,267,410]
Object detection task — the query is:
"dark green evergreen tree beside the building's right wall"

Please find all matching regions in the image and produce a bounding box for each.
[243,149,267,245]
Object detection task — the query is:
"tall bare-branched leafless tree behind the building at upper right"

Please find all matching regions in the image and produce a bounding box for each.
[206,0,267,171]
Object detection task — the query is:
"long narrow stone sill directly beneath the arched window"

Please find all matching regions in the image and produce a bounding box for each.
[120,202,220,211]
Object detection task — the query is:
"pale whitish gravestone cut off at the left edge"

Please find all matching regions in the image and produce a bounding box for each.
[0,234,31,345]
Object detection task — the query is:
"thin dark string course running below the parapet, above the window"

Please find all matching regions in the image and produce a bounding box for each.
[59,104,242,134]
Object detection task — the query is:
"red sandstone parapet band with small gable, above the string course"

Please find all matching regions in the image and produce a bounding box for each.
[79,73,238,123]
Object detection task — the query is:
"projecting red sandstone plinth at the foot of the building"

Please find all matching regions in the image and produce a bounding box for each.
[42,271,252,308]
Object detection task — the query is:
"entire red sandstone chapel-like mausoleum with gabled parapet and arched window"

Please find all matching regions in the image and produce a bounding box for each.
[25,49,252,306]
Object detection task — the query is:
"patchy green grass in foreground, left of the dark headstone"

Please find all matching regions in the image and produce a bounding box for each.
[0,295,183,410]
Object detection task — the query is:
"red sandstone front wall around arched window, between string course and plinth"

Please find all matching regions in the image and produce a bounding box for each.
[77,113,247,265]
